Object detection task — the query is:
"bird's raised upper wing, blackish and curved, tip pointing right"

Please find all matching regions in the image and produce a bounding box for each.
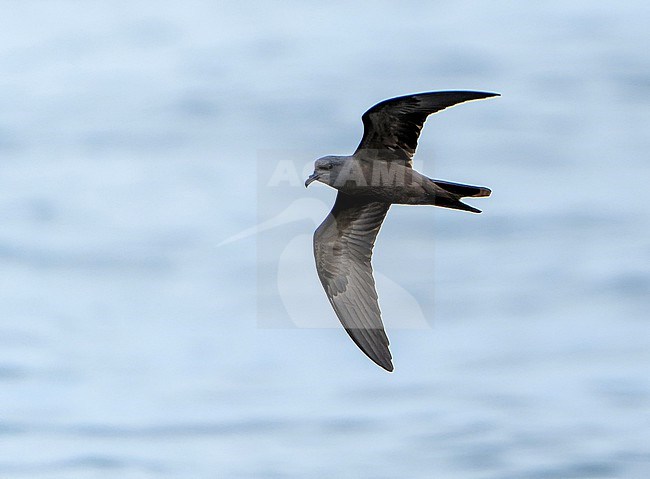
[355,91,499,167]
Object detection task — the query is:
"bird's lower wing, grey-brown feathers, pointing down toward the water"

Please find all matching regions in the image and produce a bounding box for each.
[314,192,393,371]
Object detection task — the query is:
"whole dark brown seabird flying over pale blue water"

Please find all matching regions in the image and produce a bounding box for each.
[305,91,498,371]
